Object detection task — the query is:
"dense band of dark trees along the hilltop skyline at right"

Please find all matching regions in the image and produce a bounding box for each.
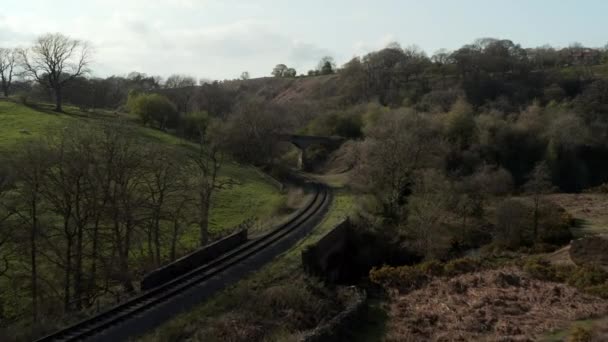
[340,38,608,108]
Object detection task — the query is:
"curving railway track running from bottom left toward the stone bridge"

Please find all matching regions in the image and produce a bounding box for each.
[37,184,331,342]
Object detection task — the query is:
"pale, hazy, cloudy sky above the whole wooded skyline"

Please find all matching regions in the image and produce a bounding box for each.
[0,0,608,80]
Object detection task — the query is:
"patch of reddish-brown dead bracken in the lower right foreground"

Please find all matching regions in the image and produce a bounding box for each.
[387,267,608,341]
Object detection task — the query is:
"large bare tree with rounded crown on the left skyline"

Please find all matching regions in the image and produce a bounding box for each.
[19,33,91,112]
